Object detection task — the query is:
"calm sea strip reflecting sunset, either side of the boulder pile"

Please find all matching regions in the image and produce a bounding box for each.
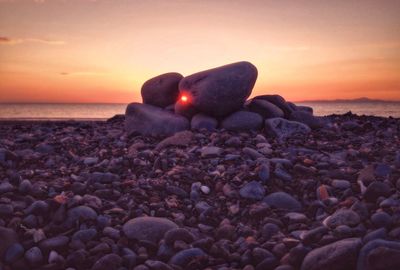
[0,102,400,120]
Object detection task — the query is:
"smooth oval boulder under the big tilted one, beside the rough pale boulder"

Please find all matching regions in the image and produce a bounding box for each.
[221,111,263,131]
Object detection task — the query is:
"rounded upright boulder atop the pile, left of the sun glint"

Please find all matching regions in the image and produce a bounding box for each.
[141,72,183,108]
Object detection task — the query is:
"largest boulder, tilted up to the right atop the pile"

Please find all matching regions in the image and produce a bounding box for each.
[179,62,257,117]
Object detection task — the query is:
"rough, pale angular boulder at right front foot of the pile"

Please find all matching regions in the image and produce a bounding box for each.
[265,118,311,139]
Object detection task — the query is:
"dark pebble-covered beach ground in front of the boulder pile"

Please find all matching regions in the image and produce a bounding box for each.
[0,114,400,270]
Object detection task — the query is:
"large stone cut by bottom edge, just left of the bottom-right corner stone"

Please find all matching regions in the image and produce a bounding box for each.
[301,238,361,270]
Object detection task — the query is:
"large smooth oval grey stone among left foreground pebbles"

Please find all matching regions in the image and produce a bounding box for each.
[122,217,178,243]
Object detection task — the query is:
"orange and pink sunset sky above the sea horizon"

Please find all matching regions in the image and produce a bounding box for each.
[0,0,400,103]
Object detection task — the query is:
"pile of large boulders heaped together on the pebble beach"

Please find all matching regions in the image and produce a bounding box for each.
[125,62,321,139]
